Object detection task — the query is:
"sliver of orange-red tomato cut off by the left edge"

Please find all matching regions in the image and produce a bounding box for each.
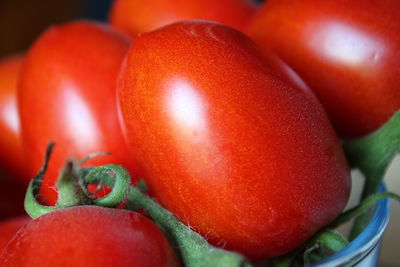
[0,55,29,181]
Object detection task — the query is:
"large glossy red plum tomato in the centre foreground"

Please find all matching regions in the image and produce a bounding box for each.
[118,21,350,260]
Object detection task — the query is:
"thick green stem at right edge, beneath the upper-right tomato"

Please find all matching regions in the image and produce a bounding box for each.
[343,112,400,239]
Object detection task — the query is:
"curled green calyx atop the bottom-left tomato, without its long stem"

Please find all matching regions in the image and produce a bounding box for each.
[25,143,130,218]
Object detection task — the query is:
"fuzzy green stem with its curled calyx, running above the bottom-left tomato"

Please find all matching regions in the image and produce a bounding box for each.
[25,144,252,267]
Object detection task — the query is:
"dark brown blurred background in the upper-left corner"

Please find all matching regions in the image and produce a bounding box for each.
[0,0,111,58]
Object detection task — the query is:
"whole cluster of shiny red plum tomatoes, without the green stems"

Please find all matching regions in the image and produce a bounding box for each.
[0,0,400,266]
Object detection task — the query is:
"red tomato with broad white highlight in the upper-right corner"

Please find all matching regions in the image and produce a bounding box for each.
[248,0,400,138]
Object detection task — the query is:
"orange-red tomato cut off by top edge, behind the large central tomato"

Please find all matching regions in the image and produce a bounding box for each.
[110,0,257,36]
